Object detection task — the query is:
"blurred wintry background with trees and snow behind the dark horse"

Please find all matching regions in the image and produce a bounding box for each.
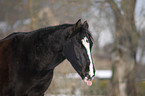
[0,0,145,96]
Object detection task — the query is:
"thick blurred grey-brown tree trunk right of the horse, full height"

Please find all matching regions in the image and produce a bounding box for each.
[107,0,138,96]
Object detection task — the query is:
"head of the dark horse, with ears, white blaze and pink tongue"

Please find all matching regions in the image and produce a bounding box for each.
[63,20,95,86]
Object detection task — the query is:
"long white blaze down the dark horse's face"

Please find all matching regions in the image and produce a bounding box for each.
[82,37,94,77]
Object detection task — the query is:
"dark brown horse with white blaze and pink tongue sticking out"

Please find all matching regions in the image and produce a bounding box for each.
[0,19,95,96]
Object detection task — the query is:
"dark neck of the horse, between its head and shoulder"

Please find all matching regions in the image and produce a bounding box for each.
[30,27,72,69]
